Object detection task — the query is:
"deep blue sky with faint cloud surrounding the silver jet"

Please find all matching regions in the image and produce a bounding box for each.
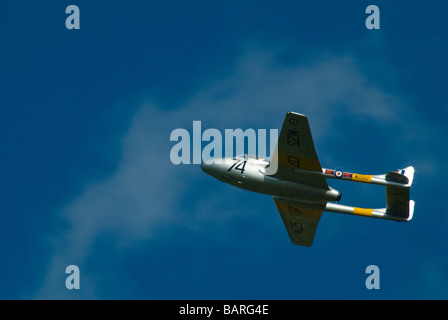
[0,1,448,299]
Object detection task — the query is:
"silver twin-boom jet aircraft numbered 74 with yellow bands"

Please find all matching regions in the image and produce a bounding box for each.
[201,112,415,247]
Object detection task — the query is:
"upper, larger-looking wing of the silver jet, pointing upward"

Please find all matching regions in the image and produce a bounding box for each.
[267,112,328,188]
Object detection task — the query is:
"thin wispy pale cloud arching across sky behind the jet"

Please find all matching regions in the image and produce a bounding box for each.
[35,43,432,298]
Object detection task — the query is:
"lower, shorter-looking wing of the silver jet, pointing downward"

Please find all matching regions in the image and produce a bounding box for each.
[274,198,323,247]
